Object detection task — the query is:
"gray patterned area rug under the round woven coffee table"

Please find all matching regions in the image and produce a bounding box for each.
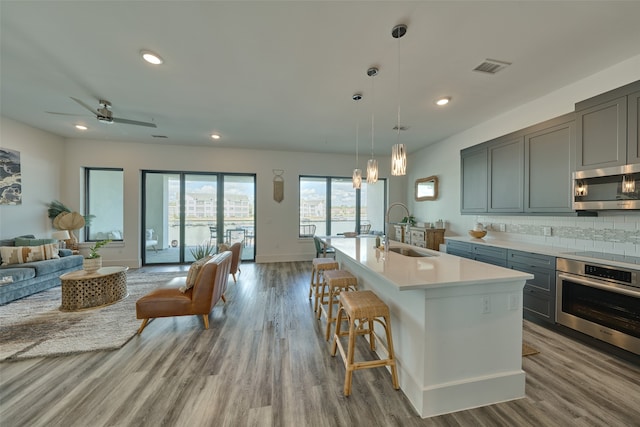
[0,271,186,361]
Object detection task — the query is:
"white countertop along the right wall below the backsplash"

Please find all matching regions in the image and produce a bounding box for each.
[445,236,640,270]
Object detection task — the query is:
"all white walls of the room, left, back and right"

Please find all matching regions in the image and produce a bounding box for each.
[6,55,640,260]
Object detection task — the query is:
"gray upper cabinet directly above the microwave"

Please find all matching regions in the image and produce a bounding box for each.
[575,81,640,170]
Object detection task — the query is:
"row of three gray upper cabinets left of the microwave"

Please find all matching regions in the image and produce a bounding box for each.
[460,113,575,214]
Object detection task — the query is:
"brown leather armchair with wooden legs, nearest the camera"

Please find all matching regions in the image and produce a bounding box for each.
[136,251,232,334]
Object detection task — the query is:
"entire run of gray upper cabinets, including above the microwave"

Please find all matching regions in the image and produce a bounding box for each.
[460,80,640,215]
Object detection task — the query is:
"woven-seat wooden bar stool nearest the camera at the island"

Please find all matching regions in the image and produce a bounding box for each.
[331,291,400,396]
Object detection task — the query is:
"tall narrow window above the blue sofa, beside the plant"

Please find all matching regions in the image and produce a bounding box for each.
[84,168,124,241]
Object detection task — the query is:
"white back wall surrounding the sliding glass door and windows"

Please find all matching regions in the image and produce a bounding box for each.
[62,140,407,267]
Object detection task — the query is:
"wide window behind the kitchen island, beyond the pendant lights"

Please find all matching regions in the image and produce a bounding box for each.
[298,176,386,237]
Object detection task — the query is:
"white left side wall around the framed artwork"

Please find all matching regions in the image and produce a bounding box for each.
[0,117,66,239]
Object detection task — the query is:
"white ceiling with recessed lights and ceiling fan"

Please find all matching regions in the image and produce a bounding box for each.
[0,0,640,157]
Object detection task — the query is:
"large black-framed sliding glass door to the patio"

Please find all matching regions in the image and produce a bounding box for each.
[142,171,255,265]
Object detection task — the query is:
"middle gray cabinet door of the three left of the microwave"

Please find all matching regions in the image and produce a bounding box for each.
[487,136,524,212]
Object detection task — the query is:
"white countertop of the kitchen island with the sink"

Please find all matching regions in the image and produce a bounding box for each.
[323,236,533,291]
